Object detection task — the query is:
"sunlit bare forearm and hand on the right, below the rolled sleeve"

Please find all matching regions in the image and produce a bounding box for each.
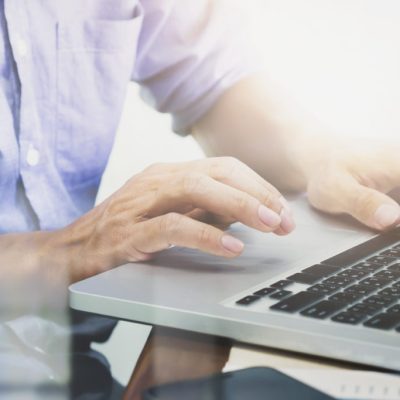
[192,76,400,230]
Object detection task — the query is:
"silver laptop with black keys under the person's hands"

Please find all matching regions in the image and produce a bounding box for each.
[70,196,400,371]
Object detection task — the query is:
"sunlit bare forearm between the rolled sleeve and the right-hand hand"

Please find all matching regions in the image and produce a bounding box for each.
[192,76,331,191]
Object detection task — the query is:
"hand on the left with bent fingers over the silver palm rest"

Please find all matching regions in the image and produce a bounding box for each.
[60,158,294,280]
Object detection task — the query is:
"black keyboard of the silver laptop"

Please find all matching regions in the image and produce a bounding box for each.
[236,228,400,333]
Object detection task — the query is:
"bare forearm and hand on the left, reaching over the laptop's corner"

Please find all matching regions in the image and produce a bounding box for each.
[0,158,293,301]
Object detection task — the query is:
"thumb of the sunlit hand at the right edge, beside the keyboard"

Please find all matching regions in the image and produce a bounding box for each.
[312,176,400,230]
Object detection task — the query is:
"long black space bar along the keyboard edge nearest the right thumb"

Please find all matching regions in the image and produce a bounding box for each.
[323,228,400,267]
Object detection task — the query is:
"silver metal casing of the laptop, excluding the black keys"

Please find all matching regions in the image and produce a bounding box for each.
[70,197,400,370]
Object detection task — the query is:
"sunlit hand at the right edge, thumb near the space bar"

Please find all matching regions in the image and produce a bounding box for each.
[307,144,400,230]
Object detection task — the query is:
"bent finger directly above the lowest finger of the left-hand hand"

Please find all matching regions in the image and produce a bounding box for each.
[147,173,282,232]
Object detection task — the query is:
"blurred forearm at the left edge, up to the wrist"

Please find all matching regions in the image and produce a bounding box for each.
[0,232,70,320]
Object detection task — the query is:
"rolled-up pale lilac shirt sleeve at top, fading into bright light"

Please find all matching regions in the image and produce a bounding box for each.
[133,0,258,135]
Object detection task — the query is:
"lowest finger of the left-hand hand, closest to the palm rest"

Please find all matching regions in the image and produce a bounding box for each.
[132,213,244,257]
